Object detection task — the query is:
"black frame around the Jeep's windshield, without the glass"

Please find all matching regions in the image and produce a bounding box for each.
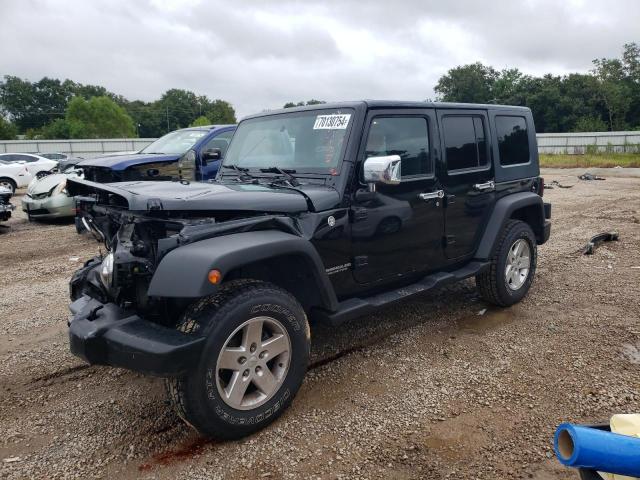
[216,106,358,178]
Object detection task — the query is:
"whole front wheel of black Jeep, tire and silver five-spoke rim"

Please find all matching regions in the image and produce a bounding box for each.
[166,280,310,440]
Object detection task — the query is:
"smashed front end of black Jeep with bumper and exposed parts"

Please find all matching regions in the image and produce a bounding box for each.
[69,181,302,377]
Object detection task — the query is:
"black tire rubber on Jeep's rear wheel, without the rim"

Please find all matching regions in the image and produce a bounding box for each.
[476,220,538,307]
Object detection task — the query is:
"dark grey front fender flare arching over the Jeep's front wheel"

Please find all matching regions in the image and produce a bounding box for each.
[148,230,338,310]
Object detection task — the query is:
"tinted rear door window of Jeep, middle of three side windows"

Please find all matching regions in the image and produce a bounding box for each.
[442,115,488,171]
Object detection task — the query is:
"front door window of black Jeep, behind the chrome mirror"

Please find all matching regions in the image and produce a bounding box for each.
[365,117,432,177]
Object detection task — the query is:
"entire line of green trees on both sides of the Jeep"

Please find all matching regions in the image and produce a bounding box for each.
[0,43,640,139]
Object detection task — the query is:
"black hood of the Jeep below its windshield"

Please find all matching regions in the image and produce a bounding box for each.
[67,178,340,213]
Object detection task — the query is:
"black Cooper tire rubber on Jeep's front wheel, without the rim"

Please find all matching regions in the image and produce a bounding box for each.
[165,280,310,440]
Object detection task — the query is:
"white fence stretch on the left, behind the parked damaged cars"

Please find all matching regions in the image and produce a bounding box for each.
[0,138,155,158]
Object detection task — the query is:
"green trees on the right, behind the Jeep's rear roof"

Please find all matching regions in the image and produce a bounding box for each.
[434,43,640,132]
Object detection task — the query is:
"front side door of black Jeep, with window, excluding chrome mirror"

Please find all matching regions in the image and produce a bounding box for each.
[351,109,444,284]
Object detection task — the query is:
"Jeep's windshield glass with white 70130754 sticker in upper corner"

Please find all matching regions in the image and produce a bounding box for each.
[224,108,353,175]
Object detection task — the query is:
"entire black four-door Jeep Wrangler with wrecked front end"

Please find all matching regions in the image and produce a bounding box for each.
[67,101,551,439]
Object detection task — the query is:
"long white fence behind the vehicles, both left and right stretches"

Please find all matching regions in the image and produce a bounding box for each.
[0,131,640,158]
